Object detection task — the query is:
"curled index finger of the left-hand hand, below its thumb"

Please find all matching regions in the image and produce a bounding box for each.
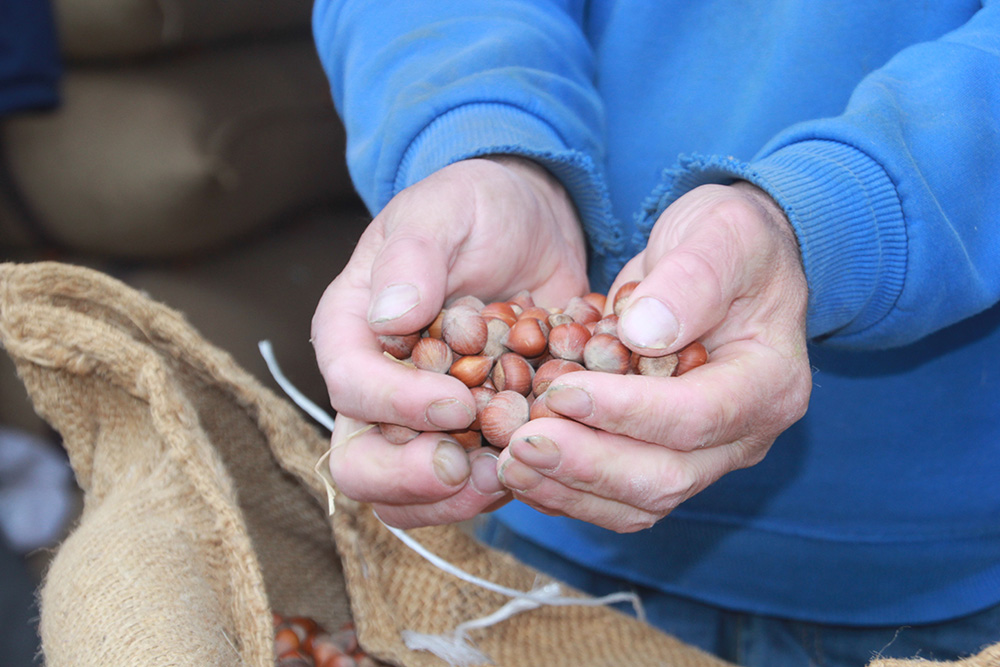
[313,274,475,431]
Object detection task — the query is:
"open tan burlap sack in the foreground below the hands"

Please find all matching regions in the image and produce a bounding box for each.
[0,263,1000,667]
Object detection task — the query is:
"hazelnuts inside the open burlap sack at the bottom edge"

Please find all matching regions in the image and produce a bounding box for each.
[274,613,381,667]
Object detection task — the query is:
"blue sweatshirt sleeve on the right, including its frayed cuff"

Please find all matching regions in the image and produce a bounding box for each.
[645,2,1000,349]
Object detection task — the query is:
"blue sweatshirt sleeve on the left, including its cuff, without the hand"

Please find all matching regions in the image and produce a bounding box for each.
[313,0,619,258]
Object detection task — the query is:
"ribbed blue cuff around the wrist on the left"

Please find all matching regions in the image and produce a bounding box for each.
[394,102,622,283]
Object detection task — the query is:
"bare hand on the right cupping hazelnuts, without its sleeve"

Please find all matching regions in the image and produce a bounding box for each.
[500,183,812,532]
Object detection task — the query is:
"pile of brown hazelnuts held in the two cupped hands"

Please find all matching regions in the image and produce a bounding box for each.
[379,282,708,449]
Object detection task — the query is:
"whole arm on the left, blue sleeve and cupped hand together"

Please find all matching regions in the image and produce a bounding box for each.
[313,2,601,526]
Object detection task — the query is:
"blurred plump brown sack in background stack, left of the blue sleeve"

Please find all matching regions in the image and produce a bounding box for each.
[0,41,352,259]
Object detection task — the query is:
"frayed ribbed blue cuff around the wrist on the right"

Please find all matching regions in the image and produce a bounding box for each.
[638,140,906,344]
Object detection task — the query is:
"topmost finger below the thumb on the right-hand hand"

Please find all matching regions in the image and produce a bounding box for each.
[544,340,812,451]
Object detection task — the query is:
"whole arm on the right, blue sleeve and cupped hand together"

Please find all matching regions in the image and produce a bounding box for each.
[492,3,1000,531]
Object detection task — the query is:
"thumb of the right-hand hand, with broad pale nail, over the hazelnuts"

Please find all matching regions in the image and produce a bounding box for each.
[619,186,767,356]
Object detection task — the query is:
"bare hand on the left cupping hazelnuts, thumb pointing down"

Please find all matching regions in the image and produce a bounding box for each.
[312,157,587,527]
